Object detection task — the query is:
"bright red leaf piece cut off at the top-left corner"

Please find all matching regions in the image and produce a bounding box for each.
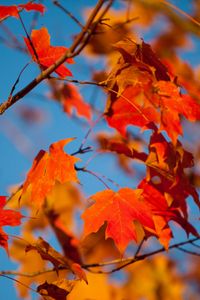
[0,3,45,21]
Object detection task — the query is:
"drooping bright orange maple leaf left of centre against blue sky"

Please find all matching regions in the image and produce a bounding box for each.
[22,138,79,206]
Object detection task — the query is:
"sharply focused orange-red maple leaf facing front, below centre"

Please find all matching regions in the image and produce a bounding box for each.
[82,188,155,252]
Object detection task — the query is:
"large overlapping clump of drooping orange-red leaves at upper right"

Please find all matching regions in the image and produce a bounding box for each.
[106,40,200,144]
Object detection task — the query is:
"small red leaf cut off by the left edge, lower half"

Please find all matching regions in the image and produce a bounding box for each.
[0,196,23,251]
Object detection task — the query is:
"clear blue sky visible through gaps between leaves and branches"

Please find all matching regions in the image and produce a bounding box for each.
[0,0,200,300]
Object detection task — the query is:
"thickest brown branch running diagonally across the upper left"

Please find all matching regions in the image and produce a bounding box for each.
[0,0,114,114]
